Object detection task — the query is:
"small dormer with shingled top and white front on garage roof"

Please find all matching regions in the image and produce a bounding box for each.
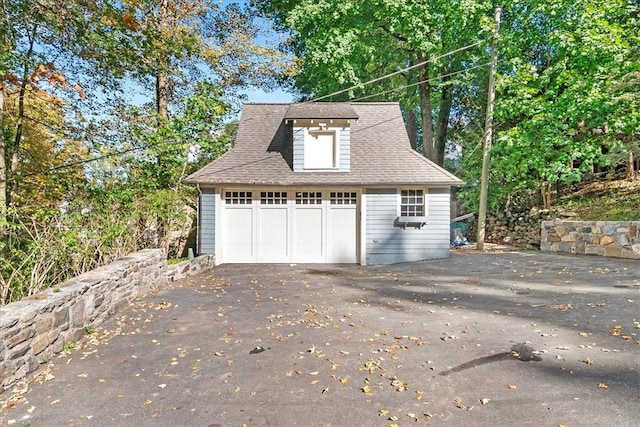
[285,103,358,172]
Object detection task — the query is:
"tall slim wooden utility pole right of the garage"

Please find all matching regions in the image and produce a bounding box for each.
[476,7,502,251]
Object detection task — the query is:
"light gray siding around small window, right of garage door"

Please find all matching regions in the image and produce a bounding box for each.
[365,188,450,264]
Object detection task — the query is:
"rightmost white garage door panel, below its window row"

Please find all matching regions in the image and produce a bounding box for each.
[327,208,356,263]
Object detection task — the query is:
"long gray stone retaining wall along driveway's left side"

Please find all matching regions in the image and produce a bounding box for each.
[0,249,214,394]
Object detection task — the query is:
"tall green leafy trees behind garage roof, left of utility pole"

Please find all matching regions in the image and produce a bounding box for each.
[258,0,491,164]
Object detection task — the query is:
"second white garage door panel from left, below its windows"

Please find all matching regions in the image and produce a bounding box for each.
[258,207,289,262]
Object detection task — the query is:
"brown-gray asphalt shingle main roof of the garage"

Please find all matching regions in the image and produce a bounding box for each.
[185,102,462,186]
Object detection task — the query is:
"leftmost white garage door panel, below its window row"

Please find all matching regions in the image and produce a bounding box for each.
[223,207,255,262]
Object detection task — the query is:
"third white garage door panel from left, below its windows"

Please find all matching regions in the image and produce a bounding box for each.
[293,207,324,262]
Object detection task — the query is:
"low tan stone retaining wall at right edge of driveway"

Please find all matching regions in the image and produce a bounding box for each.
[540,221,640,259]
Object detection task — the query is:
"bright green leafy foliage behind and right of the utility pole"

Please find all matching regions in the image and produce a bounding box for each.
[462,0,639,209]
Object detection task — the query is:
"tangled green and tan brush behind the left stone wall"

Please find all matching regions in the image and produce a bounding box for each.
[0,186,193,304]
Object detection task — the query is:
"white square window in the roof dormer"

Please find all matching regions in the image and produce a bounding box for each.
[304,130,340,169]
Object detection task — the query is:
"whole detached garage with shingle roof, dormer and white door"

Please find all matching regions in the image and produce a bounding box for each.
[186,102,462,265]
